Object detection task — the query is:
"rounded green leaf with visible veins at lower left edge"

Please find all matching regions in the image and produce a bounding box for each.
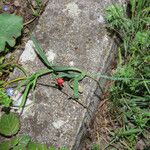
[0,113,20,136]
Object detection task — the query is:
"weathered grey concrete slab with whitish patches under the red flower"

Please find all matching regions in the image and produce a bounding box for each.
[17,0,123,150]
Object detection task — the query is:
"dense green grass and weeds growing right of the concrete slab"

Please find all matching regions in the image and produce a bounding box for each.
[106,0,150,149]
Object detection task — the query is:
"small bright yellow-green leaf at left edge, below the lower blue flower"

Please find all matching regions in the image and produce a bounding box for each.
[0,90,12,107]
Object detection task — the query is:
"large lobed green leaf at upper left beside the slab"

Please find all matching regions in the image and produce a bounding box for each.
[0,13,23,52]
